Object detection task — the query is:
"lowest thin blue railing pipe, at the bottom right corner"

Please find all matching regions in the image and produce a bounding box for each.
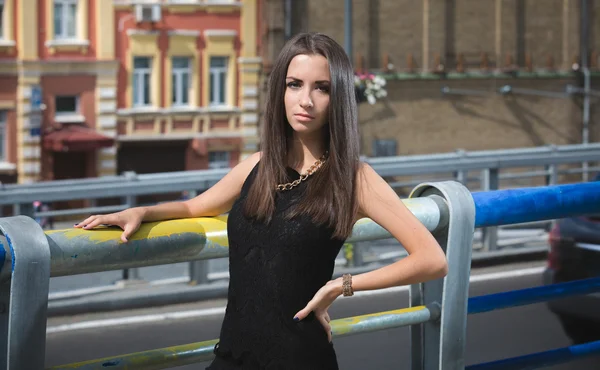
[465,341,600,370]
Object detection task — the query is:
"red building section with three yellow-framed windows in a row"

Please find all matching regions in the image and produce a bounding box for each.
[115,0,261,173]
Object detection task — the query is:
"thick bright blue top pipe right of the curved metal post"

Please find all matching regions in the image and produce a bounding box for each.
[473,181,600,227]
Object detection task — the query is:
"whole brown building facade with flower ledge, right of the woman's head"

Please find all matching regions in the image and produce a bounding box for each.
[262,0,600,156]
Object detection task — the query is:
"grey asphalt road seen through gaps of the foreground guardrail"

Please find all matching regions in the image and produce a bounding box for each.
[46,263,600,370]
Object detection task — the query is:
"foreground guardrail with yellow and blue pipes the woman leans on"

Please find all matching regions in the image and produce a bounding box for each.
[0,182,600,370]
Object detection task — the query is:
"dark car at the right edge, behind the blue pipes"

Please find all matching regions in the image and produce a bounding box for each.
[544,175,600,343]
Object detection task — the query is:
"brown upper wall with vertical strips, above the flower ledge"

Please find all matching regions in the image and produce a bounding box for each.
[286,0,600,71]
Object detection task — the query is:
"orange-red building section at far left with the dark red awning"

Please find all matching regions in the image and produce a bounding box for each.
[0,0,118,183]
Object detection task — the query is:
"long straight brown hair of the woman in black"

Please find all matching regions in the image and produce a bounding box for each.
[244,33,359,239]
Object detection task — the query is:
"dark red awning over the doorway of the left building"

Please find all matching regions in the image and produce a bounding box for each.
[43,125,115,152]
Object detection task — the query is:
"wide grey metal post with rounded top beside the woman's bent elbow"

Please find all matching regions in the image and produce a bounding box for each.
[410,181,475,370]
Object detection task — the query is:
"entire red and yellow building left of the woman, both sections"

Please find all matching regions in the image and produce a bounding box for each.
[0,0,261,183]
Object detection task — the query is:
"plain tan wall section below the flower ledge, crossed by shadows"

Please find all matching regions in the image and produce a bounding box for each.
[359,79,584,155]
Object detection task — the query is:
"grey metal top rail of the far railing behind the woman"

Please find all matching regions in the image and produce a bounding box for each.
[0,143,600,208]
